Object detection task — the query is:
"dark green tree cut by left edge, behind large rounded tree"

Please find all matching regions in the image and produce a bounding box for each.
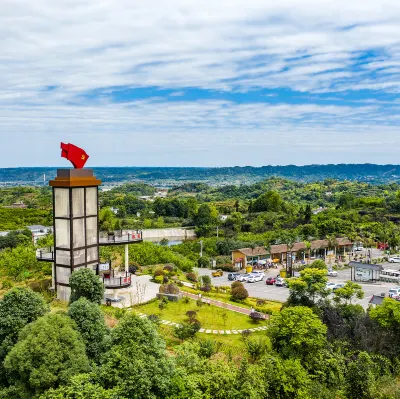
[0,288,49,360]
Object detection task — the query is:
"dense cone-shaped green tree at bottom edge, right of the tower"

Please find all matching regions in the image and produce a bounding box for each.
[94,314,174,399]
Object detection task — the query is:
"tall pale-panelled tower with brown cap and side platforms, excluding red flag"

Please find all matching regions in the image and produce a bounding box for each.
[35,168,142,301]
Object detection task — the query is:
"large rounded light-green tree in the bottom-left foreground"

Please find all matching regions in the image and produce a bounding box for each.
[4,314,89,394]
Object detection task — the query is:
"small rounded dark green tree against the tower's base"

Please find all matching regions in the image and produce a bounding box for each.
[69,268,104,305]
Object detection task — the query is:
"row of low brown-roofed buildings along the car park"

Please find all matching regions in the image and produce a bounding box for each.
[232,237,353,267]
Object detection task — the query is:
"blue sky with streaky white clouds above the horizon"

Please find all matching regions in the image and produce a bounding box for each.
[0,0,400,167]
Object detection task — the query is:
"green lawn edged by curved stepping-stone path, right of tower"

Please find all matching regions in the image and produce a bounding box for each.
[136,299,267,330]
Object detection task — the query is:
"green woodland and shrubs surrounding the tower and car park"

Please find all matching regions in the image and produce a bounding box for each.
[0,177,400,399]
